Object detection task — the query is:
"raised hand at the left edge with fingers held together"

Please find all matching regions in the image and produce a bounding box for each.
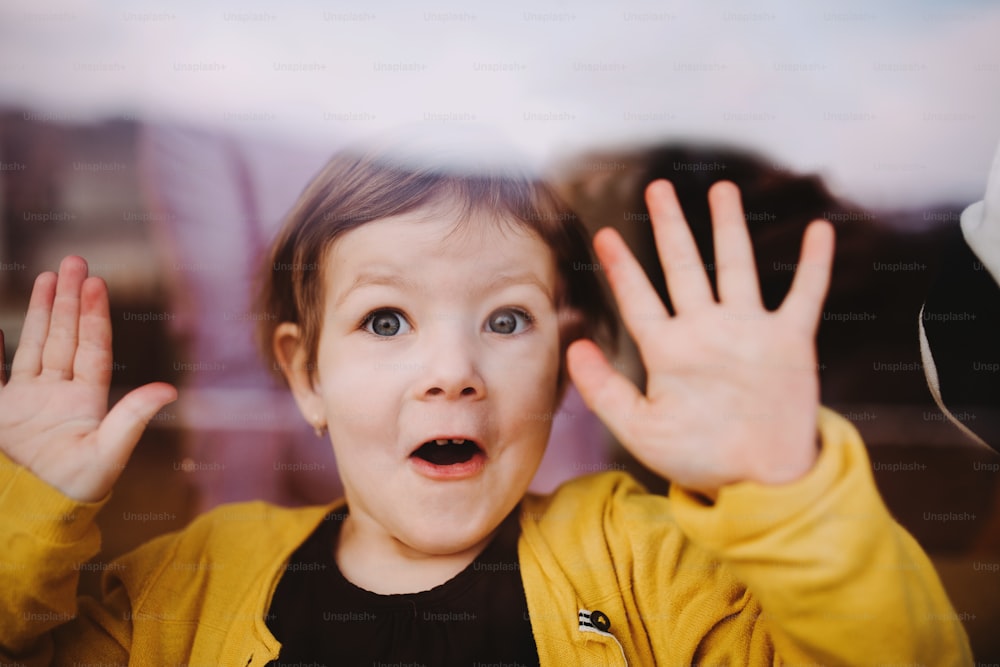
[0,257,177,501]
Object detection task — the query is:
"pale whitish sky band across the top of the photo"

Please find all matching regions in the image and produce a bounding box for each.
[0,0,1000,207]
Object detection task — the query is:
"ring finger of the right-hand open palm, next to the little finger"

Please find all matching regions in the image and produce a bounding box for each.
[708,181,763,308]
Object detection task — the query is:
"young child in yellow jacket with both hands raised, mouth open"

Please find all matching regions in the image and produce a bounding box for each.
[0,145,972,666]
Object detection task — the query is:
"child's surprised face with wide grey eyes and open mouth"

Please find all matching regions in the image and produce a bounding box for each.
[286,206,560,554]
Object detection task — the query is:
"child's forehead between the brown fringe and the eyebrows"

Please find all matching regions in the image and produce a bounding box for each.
[324,206,557,297]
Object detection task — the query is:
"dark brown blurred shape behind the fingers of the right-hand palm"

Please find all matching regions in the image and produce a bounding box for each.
[567,143,992,414]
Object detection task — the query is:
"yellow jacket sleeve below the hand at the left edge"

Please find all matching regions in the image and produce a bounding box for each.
[0,455,146,666]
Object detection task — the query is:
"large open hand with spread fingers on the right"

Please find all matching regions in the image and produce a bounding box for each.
[567,181,833,498]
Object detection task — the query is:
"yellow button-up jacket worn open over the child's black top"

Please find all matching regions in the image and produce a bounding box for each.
[0,411,972,667]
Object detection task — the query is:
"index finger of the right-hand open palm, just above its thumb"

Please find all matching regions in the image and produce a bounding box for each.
[594,227,669,351]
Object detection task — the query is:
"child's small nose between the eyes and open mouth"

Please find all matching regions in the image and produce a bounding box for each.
[417,327,486,400]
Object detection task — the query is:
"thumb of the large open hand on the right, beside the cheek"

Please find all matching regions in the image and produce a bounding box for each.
[566,339,644,443]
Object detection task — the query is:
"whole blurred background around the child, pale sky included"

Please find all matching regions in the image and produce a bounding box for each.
[0,0,1000,660]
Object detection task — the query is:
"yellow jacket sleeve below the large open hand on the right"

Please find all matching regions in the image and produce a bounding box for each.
[670,410,972,665]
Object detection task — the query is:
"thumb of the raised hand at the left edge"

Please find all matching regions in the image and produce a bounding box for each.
[97,382,177,465]
